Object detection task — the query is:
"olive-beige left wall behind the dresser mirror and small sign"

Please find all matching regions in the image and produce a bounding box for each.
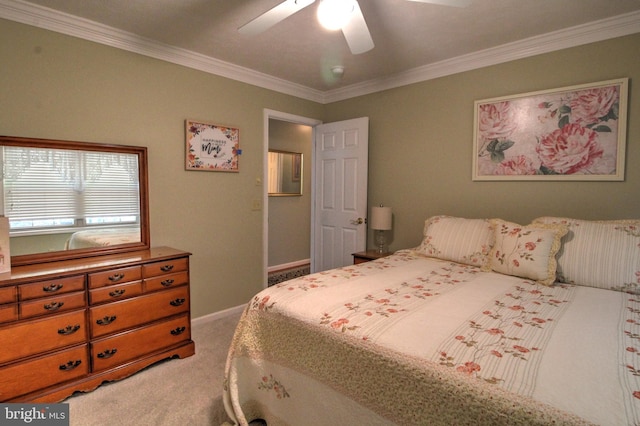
[0,20,324,317]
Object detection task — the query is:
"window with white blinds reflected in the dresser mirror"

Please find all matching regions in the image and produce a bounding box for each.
[2,146,140,231]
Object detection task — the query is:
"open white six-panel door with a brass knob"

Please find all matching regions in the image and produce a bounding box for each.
[311,117,369,272]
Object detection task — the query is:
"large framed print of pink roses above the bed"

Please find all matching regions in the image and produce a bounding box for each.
[473,78,628,181]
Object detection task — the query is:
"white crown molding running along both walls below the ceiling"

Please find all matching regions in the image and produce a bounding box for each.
[0,0,640,104]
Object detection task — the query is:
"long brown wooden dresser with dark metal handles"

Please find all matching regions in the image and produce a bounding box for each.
[0,247,195,402]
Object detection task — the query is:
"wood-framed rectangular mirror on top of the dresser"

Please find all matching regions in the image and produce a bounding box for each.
[0,136,150,266]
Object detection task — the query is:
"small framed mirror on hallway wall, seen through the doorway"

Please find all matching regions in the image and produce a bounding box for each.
[268,150,302,197]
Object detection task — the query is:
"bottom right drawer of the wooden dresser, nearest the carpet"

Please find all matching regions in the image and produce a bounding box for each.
[91,314,191,371]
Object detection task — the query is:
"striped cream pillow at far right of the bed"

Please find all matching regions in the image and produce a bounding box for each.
[534,217,640,293]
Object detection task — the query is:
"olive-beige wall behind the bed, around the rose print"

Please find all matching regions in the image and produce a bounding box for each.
[326,34,640,250]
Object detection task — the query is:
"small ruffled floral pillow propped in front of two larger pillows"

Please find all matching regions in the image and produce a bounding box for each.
[483,219,567,285]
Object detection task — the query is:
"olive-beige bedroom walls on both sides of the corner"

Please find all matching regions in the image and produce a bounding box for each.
[0,20,640,317]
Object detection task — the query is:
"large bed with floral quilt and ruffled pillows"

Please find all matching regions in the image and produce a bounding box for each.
[224,216,640,426]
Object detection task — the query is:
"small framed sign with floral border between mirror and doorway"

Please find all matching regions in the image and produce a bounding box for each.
[186,120,242,172]
